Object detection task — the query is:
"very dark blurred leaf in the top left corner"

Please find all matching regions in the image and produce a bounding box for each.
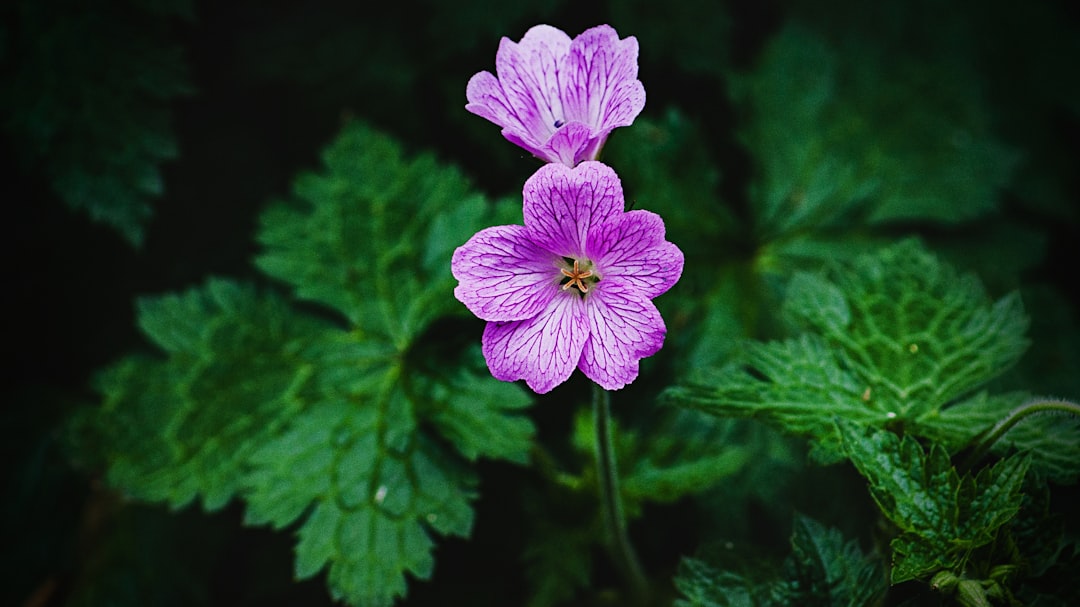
[0,0,191,246]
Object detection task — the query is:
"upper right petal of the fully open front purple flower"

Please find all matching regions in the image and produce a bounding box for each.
[585,211,684,299]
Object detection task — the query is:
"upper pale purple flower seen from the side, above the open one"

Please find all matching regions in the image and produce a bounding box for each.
[465,25,645,166]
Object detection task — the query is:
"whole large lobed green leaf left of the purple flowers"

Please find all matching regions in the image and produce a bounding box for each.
[69,124,532,606]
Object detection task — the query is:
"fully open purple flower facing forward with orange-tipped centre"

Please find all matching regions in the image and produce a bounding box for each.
[450,162,683,393]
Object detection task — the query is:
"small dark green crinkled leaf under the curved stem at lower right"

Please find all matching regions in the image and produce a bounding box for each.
[837,421,1028,584]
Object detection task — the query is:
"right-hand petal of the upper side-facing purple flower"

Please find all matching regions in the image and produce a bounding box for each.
[563,25,645,131]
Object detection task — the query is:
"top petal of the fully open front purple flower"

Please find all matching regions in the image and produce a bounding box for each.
[524,161,624,257]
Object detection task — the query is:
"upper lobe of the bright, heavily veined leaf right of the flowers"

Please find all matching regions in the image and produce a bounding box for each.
[784,240,1028,419]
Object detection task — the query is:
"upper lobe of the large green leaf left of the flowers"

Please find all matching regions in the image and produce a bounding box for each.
[255,123,486,349]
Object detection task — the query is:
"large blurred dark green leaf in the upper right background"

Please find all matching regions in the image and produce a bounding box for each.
[731,24,1017,240]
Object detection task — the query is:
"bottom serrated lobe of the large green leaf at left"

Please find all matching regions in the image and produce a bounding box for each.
[247,386,475,606]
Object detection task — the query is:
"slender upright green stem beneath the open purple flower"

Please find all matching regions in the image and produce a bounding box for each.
[593,383,649,605]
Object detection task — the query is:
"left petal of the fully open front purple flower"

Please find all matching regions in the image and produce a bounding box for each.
[450,226,562,321]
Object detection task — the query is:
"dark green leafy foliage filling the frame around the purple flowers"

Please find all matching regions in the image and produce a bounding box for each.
[14,0,1080,607]
